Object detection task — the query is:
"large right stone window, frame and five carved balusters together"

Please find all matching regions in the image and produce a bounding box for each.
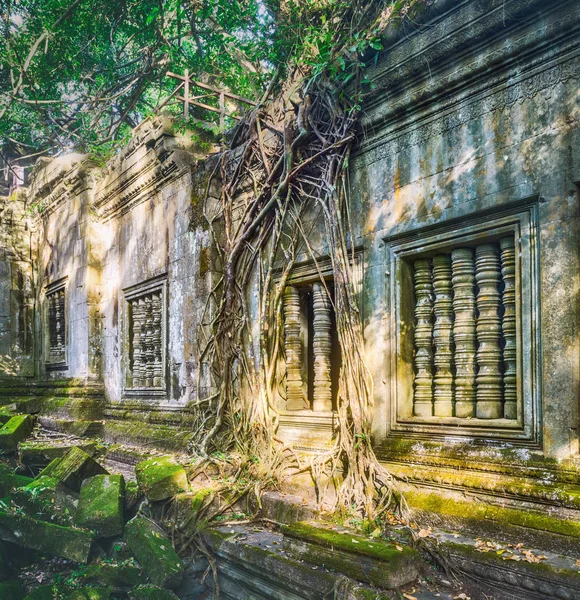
[386,203,541,442]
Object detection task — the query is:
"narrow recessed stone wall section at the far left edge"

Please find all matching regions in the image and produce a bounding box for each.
[0,196,34,377]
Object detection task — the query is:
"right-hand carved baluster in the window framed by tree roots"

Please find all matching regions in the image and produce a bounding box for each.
[312,283,332,411]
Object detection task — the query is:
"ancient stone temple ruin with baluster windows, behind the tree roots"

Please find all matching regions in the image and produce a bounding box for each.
[0,0,580,600]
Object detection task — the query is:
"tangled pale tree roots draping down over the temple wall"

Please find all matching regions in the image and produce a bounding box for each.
[188,1,428,521]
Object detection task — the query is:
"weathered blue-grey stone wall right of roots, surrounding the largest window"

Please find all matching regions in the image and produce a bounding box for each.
[351,0,580,458]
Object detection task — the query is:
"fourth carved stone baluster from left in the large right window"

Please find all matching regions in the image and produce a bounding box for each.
[475,244,503,419]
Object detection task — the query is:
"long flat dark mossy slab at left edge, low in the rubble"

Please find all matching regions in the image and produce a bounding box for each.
[0,510,94,560]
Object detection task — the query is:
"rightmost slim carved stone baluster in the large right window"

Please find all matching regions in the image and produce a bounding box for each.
[499,237,518,419]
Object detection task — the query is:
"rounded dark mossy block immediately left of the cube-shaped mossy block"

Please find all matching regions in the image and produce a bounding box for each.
[11,476,77,525]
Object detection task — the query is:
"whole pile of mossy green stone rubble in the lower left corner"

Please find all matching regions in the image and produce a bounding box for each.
[0,411,189,600]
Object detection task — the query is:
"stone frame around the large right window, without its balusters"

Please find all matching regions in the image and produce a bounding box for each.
[383,198,542,447]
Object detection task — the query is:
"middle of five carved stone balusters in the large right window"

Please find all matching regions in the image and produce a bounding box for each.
[451,248,476,418]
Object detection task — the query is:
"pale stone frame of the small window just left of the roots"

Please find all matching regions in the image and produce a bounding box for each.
[120,274,168,400]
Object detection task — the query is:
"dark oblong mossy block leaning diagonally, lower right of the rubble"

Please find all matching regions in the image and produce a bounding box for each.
[125,517,184,588]
